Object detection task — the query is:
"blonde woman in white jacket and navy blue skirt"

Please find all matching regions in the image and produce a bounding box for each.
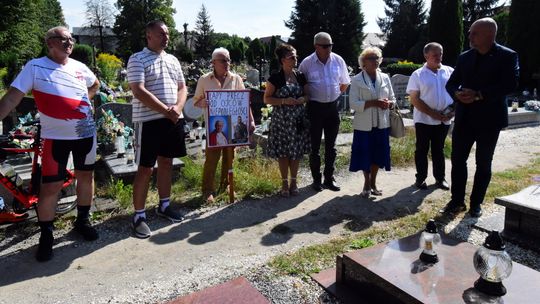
[349,47,395,197]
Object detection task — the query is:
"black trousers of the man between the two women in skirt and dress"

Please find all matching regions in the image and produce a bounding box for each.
[307,100,340,183]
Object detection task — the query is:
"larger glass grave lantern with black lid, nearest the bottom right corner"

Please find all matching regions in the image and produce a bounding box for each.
[473,230,512,296]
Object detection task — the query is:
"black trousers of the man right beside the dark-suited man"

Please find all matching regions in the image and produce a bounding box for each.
[414,123,450,181]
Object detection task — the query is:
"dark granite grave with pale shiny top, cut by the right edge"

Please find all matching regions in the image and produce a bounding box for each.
[495,185,540,250]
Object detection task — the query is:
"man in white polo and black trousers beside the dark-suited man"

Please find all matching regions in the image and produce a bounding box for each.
[407,42,454,190]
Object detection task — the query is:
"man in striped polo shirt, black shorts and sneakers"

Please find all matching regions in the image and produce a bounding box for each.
[127,21,187,238]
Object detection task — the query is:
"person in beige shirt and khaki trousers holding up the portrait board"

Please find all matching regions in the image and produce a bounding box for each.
[194,47,255,203]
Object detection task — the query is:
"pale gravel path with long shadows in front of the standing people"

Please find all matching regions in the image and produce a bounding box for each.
[0,126,540,304]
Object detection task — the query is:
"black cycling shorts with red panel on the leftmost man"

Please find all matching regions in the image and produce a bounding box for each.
[41,136,97,183]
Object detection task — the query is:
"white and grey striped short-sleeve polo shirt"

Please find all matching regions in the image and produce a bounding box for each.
[127,48,185,122]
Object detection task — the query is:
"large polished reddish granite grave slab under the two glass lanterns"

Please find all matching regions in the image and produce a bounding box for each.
[312,234,540,304]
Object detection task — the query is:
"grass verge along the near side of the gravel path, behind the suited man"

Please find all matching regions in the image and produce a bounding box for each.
[269,158,540,279]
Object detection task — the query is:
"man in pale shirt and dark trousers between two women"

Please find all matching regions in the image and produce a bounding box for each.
[298,32,351,191]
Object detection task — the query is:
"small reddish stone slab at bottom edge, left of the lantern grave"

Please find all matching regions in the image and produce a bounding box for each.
[163,277,270,304]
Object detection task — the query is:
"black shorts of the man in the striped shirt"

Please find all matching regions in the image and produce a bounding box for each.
[134,118,187,167]
